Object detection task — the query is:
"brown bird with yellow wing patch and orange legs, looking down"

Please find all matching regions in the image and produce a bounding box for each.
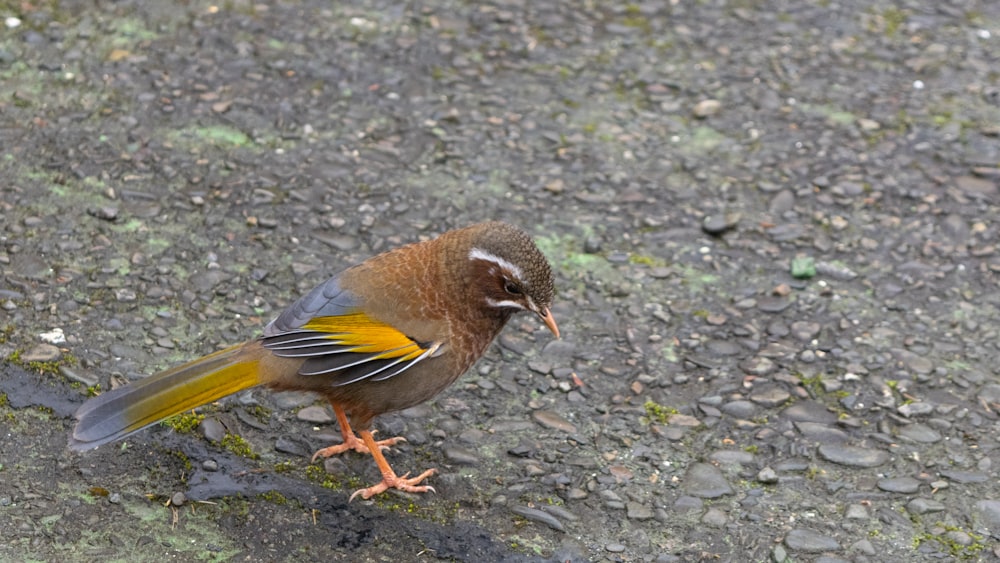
[69,221,559,500]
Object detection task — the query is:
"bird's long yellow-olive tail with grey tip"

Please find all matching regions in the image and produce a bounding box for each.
[69,344,261,451]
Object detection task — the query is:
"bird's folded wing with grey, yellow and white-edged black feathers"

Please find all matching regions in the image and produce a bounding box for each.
[262,277,441,386]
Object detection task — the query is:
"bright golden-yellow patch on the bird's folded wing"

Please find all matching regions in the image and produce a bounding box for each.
[302,313,427,361]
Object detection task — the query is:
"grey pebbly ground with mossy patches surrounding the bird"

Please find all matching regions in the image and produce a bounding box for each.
[0,0,1000,562]
